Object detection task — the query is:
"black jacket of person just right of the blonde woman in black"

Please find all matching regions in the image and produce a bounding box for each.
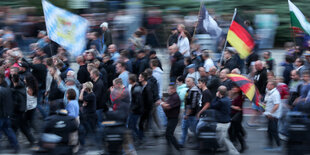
[92,78,108,111]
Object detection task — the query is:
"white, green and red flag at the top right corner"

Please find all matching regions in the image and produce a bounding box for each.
[288,0,310,34]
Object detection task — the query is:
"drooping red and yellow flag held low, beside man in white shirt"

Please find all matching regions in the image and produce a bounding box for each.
[227,74,259,106]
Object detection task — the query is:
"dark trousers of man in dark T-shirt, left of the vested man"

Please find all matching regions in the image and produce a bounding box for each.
[166,118,180,150]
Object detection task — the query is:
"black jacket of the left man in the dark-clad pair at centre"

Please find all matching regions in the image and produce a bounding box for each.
[130,84,143,114]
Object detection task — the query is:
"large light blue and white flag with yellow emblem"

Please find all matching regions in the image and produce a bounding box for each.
[42,0,88,56]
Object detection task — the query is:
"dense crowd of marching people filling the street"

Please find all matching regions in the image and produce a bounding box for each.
[0,11,310,154]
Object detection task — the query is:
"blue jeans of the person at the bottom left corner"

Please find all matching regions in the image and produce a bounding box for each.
[0,118,19,149]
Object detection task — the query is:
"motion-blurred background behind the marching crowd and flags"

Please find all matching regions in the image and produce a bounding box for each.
[0,0,310,48]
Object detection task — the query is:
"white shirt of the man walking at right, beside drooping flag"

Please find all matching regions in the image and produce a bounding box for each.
[264,88,281,118]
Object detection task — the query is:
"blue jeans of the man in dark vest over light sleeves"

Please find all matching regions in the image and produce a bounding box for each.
[180,116,198,145]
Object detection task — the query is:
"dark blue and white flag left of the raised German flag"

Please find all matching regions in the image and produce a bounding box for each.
[197,5,222,37]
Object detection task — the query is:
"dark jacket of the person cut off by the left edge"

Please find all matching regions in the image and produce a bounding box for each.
[0,86,14,118]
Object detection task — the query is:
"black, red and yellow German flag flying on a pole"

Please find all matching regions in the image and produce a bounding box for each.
[227,14,255,59]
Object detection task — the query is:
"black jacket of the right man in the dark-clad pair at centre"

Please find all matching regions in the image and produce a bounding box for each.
[142,84,154,113]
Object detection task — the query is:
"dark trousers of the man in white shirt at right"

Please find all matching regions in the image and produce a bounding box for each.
[267,118,280,147]
